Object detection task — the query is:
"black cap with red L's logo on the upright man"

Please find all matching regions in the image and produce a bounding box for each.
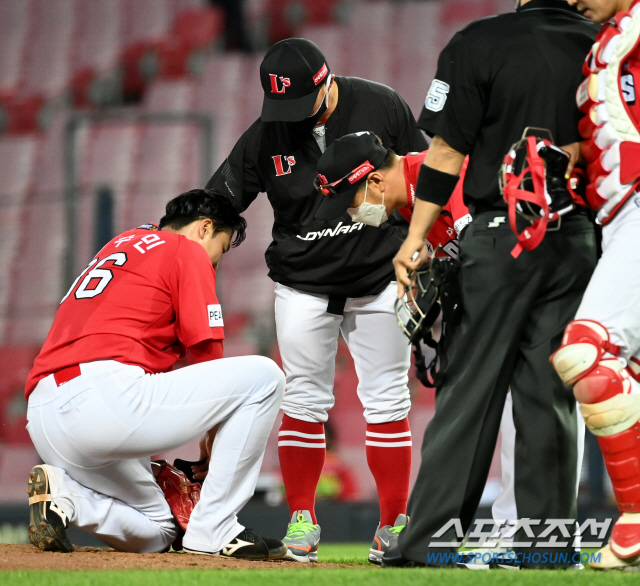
[260,39,329,122]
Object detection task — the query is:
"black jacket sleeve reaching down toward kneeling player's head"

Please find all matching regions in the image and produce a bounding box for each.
[206,124,264,212]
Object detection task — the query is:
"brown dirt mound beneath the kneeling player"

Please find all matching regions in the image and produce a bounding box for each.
[0,543,364,571]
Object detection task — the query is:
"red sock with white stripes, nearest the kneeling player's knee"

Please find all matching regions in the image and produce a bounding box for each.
[278,414,327,524]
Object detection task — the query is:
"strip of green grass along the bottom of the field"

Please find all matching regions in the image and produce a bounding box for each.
[5,543,640,586]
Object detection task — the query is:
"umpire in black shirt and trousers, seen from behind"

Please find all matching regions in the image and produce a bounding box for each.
[383,0,597,568]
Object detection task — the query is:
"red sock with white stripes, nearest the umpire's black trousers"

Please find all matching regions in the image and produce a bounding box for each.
[366,417,411,527]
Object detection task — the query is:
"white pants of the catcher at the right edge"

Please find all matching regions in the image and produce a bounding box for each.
[575,194,640,368]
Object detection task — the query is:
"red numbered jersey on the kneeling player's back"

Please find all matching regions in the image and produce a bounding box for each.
[26,225,224,398]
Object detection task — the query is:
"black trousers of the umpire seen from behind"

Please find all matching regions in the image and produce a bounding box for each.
[399,210,597,567]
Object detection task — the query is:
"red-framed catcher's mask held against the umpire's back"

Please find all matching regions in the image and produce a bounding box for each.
[499,128,582,258]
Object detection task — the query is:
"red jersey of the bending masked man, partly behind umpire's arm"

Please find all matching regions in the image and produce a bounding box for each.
[398,151,471,258]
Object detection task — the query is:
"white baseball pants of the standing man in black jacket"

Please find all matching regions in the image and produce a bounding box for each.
[275,282,411,424]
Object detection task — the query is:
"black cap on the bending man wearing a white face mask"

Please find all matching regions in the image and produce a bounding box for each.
[314,132,389,220]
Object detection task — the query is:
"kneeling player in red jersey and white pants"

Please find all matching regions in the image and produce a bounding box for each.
[26,190,287,559]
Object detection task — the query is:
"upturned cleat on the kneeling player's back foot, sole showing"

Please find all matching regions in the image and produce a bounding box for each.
[27,465,73,553]
